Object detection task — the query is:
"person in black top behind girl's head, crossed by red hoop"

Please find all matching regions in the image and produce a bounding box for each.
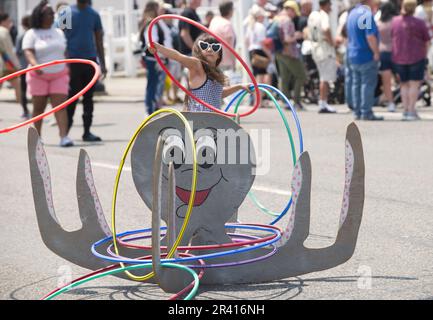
[179,0,202,55]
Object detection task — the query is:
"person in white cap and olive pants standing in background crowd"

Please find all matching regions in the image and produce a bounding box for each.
[275,0,306,109]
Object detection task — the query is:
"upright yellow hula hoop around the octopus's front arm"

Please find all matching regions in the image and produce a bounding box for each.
[111,109,197,281]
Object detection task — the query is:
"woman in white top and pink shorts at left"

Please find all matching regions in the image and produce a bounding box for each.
[23,0,74,147]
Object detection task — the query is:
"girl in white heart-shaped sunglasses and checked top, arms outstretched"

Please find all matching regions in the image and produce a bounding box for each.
[149,34,251,111]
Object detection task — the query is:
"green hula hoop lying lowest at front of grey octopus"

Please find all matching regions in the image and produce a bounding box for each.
[42,263,200,300]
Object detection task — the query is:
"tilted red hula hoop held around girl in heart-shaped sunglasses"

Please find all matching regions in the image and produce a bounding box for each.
[147,14,261,117]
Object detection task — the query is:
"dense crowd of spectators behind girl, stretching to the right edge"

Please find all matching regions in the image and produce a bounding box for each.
[143,0,433,121]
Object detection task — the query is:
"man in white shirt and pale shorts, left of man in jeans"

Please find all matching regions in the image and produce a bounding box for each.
[308,0,337,113]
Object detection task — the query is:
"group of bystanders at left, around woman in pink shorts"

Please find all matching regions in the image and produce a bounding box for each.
[0,0,107,147]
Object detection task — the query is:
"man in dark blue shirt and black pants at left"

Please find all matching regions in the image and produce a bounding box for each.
[64,0,107,142]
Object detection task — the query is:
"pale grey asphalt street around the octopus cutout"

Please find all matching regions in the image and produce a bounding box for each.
[0,97,433,300]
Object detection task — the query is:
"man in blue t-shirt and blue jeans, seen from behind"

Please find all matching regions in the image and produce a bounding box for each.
[346,0,383,120]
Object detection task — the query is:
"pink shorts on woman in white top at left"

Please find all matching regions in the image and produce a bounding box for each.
[27,67,69,97]
